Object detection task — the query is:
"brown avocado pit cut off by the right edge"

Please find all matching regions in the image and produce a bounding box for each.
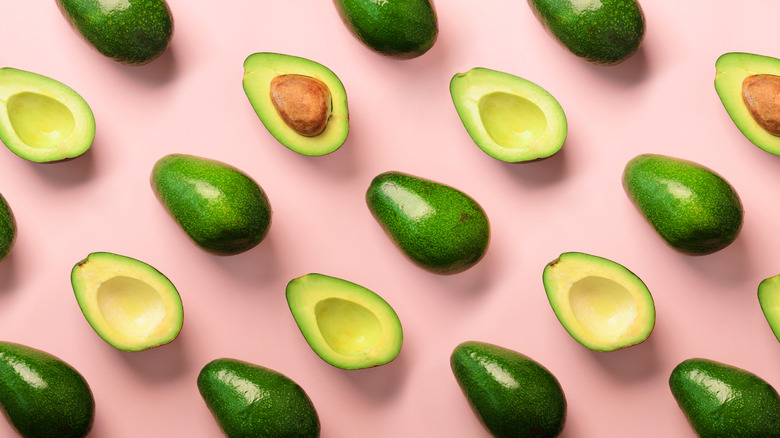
[742,74,780,136]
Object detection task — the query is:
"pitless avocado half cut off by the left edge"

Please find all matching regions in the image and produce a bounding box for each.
[0,67,95,163]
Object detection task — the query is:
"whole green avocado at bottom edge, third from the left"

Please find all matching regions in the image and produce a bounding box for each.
[450,341,566,438]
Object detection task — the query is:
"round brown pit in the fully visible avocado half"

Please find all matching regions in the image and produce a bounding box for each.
[271,74,331,137]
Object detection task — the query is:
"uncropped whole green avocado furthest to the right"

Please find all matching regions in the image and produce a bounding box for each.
[623,154,744,255]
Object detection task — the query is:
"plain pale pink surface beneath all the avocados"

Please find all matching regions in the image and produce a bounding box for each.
[0,0,780,438]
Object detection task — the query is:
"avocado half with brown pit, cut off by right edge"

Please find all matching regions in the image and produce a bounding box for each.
[715,52,780,155]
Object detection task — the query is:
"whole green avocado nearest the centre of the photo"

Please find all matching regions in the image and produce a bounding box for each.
[366,171,490,275]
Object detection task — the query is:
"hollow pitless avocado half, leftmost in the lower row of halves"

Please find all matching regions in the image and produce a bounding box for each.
[70,252,184,351]
